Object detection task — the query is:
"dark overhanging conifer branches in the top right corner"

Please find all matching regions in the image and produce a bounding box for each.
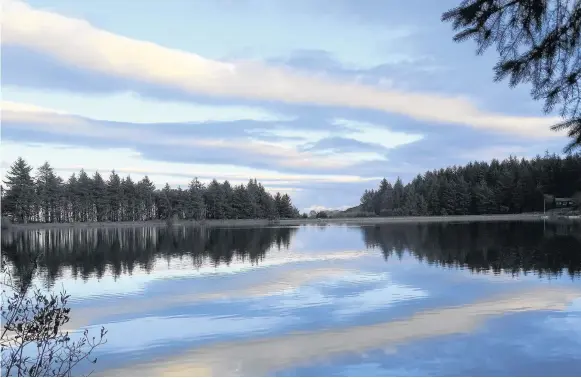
[442,0,581,152]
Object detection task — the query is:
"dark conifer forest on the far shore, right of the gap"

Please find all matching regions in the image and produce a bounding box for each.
[359,153,581,216]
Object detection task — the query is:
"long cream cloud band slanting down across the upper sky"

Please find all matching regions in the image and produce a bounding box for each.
[2,0,564,138]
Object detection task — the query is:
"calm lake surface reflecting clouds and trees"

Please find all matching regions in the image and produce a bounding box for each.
[2,223,581,376]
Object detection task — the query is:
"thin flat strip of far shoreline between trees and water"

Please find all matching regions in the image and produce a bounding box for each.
[4,213,568,231]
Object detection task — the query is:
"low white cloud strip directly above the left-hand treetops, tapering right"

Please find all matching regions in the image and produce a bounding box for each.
[0,141,375,193]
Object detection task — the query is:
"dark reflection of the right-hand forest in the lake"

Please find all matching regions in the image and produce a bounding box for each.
[362,222,581,278]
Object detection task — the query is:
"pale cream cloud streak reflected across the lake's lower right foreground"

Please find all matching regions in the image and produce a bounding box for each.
[107,289,581,376]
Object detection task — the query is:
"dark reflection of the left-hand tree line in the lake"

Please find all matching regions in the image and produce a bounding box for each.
[2,227,296,287]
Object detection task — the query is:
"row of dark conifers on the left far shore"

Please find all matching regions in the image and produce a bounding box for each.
[1,158,300,223]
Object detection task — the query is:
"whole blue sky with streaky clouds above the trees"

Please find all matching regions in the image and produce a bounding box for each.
[0,0,567,211]
